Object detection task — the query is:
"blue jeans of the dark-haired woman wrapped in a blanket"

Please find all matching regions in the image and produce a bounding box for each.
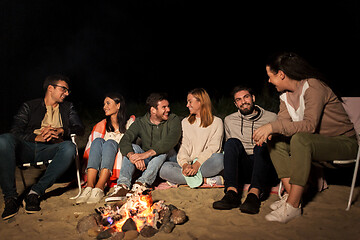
[87,138,119,173]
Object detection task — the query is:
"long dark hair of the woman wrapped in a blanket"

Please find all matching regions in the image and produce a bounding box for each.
[105,92,128,133]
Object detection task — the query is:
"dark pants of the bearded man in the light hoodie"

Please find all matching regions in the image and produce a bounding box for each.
[224,138,279,195]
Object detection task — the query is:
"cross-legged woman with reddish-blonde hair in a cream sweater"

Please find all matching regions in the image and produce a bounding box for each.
[160,88,224,188]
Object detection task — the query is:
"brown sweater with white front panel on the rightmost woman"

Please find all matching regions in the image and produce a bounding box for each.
[271,78,355,137]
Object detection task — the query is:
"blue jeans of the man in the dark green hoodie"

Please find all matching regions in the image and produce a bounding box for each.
[117,144,168,188]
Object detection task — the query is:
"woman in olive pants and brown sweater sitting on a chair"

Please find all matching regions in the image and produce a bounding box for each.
[253,53,358,223]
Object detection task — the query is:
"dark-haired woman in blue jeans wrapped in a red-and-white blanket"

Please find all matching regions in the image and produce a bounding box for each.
[76,93,135,204]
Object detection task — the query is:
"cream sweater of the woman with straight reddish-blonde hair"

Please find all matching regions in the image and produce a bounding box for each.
[177,116,224,166]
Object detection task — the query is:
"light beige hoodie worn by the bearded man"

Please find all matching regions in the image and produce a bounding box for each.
[224,105,276,155]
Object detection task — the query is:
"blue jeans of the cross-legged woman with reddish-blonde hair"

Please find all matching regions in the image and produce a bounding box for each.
[159,153,224,184]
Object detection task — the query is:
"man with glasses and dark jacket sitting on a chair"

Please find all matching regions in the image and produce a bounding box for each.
[0,75,84,220]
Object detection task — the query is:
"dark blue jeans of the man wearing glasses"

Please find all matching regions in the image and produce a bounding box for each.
[0,133,76,199]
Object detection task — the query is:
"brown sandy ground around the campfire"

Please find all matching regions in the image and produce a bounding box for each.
[0,166,360,240]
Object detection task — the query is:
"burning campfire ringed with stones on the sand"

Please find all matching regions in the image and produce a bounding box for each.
[77,185,187,239]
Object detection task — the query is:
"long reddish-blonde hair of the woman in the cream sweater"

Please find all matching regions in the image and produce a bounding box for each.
[188,88,214,128]
